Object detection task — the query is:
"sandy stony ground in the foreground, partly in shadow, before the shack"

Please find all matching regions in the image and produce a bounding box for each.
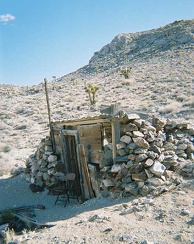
[0,174,194,244]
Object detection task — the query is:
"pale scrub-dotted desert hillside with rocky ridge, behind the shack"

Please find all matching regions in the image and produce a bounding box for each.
[0,20,194,174]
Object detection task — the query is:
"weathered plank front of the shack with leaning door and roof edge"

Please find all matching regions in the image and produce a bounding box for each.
[50,104,139,199]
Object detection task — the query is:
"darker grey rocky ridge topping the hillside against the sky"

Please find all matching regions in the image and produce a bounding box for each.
[73,19,194,74]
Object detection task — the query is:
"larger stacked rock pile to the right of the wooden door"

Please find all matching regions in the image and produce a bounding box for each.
[101,117,194,197]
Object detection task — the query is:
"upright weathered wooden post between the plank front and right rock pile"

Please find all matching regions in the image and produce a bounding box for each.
[111,104,120,163]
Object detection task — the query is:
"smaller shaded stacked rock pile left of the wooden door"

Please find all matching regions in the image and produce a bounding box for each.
[26,137,65,190]
